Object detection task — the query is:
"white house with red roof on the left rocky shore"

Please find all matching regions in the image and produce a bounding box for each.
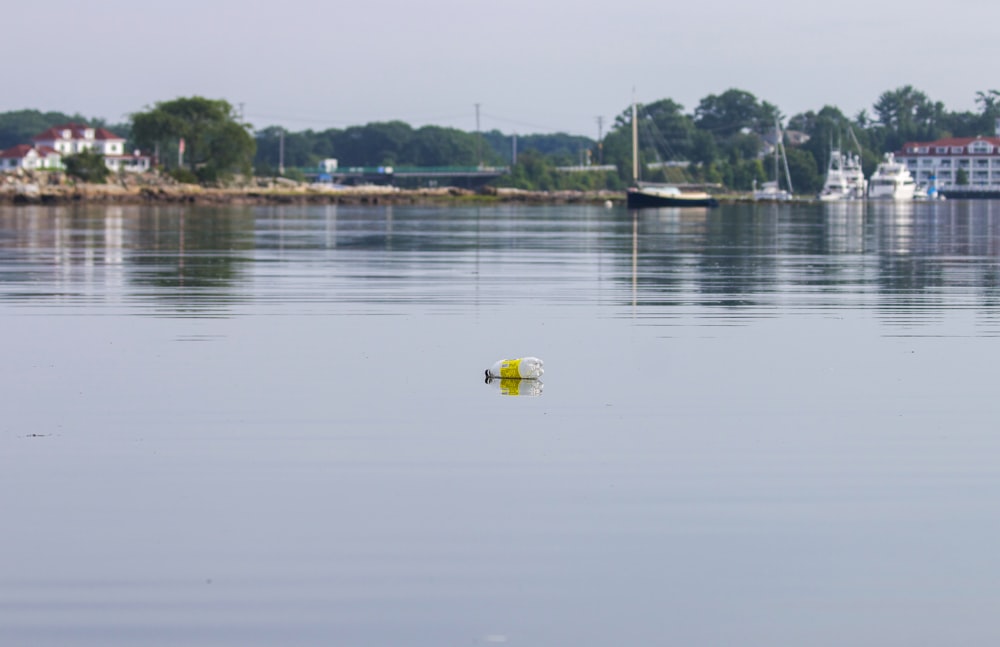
[0,124,149,172]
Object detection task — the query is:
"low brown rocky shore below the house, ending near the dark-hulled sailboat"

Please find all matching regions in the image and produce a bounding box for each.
[0,173,625,205]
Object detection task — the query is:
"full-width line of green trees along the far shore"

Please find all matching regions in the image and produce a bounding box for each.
[0,85,1000,193]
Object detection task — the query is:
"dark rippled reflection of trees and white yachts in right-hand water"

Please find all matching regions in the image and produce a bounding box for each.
[622,201,1000,324]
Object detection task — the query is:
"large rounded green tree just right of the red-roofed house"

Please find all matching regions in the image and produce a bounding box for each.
[132,96,256,179]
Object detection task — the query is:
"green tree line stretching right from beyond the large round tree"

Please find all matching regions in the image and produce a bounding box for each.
[246,86,1000,193]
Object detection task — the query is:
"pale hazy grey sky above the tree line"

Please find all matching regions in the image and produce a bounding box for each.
[7,0,1000,137]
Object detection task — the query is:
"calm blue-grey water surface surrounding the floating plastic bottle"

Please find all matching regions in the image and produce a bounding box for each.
[0,202,1000,647]
